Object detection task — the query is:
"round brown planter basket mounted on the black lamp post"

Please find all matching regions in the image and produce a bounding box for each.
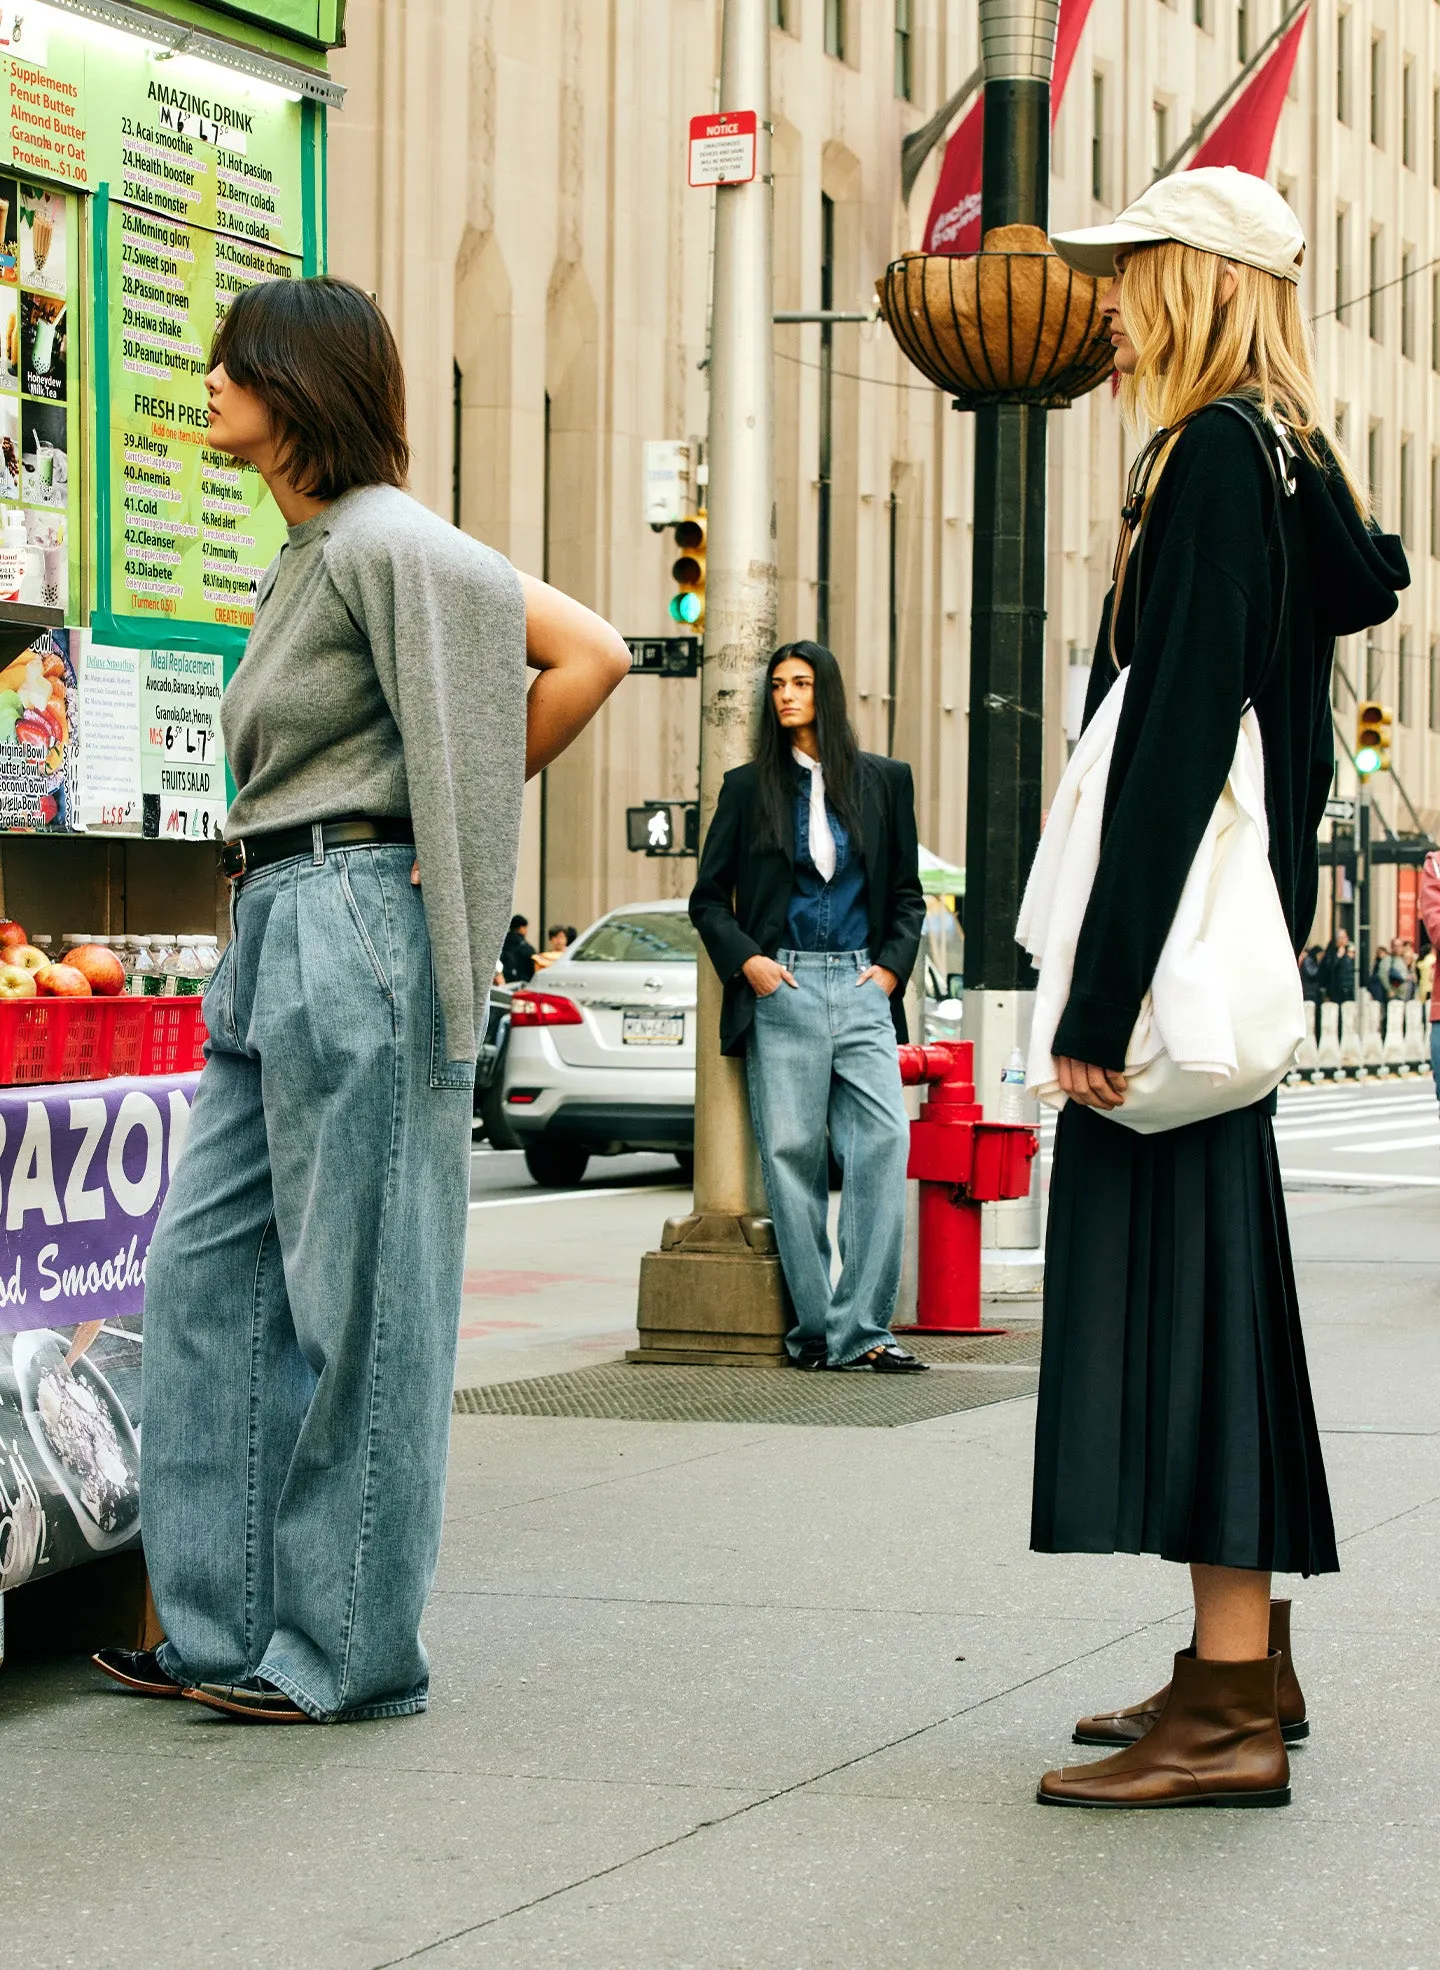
[875,227,1115,410]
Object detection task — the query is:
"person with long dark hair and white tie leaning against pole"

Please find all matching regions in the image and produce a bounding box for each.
[689,642,924,1373]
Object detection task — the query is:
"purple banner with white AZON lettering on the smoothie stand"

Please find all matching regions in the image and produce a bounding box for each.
[0,1074,199,1334]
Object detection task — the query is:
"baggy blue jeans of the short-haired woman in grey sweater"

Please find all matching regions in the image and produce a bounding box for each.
[140,845,475,1720]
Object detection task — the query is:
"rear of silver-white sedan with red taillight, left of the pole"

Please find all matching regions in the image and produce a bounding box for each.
[504,900,699,1186]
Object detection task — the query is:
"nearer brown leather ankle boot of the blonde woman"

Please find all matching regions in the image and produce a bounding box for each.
[1034,1649,1290,1806]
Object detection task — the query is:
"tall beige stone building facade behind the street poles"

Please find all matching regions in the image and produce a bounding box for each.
[329,0,1440,945]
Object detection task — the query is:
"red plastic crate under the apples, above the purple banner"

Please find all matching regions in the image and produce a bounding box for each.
[0,995,205,1087]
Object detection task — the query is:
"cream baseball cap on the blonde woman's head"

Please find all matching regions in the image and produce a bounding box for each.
[1050,164,1304,280]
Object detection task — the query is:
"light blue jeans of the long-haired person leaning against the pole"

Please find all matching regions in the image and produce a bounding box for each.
[745,952,910,1367]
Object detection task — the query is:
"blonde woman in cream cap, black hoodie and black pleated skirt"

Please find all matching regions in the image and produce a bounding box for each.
[1030,169,1408,1806]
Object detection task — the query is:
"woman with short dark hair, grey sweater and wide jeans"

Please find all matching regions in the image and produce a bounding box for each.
[97,280,628,1724]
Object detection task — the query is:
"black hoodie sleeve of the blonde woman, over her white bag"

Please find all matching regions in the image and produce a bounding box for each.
[1054,420,1271,1070]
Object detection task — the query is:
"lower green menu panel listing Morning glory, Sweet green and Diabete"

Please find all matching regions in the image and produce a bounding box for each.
[106,205,299,628]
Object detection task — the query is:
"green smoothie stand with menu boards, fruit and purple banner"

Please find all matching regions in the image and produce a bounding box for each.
[0,0,343,1653]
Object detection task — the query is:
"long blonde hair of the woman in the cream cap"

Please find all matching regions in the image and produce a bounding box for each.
[1121,240,1369,518]
